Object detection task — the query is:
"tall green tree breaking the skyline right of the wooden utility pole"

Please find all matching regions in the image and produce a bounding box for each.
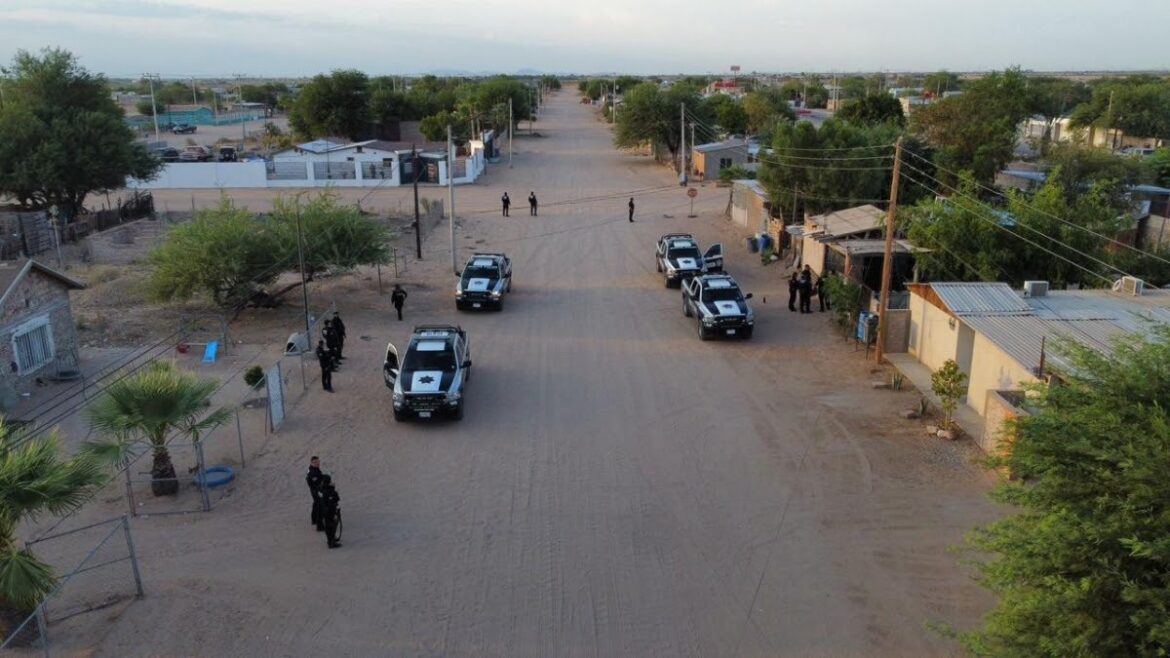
[910,69,1033,183]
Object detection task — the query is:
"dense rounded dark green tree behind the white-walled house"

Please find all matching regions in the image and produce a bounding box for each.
[289,70,371,139]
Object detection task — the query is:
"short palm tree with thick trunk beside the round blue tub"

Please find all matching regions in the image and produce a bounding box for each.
[85,361,229,495]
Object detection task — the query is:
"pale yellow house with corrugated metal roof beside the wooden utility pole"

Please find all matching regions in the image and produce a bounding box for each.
[890,277,1170,452]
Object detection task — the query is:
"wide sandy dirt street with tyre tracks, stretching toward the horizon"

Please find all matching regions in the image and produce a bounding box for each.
[20,92,996,658]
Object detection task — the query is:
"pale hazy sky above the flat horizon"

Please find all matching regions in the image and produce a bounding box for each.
[0,0,1170,77]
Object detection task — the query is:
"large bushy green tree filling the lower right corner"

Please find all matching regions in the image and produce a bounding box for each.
[962,324,1170,657]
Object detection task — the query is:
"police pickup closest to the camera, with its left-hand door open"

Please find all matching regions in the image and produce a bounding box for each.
[383,324,472,421]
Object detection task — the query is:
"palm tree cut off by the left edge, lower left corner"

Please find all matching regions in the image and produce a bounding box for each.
[0,419,106,622]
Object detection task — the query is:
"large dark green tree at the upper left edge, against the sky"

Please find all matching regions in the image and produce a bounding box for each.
[0,49,161,221]
